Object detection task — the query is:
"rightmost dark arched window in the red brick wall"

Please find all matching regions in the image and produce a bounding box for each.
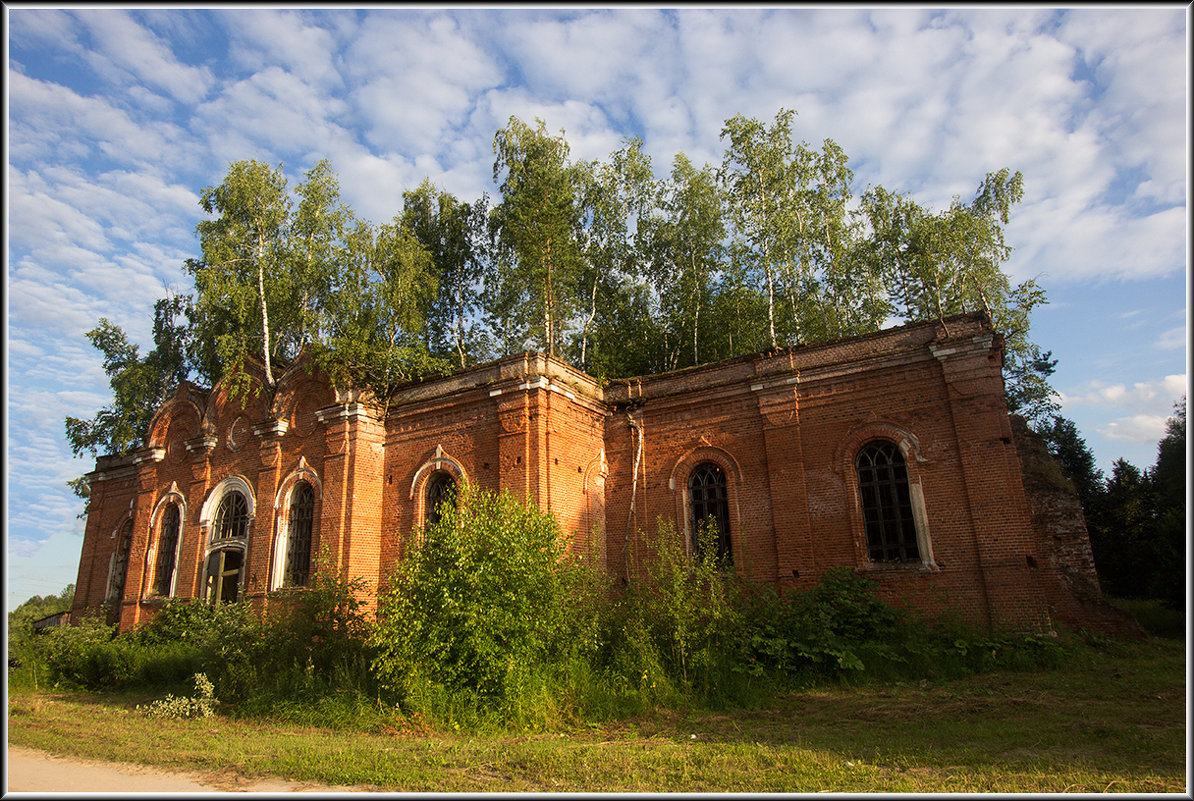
[855,442,921,562]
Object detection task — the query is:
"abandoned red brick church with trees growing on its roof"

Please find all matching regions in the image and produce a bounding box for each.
[73,314,1122,630]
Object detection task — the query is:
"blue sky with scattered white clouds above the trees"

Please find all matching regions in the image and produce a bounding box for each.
[5,5,1189,604]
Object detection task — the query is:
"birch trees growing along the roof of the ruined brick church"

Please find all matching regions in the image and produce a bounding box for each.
[66,109,1057,479]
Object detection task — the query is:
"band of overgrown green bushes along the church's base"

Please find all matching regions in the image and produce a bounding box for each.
[23,498,1067,728]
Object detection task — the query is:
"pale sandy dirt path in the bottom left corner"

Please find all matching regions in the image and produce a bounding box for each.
[6,745,363,794]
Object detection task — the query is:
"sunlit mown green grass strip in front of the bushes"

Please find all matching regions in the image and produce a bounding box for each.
[8,637,1187,793]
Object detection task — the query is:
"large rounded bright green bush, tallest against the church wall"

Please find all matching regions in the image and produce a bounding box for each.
[373,487,585,703]
